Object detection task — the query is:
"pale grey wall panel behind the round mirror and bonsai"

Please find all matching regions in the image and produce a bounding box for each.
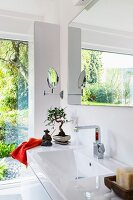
[34,22,60,137]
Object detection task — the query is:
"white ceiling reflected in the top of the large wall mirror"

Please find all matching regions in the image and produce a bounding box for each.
[73,0,133,32]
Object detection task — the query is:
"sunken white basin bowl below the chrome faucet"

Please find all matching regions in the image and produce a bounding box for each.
[38,149,112,180]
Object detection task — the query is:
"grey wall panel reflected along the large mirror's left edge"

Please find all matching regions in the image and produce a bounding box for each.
[68,27,81,104]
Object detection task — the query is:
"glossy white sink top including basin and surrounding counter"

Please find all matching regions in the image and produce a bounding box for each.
[27,144,125,200]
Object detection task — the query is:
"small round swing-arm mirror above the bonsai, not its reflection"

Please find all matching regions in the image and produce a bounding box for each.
[47,67,59,89]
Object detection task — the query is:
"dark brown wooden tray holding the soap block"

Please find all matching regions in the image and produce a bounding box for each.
[104,176,133,200]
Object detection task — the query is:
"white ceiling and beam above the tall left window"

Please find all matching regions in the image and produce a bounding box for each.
[0,0,59,36]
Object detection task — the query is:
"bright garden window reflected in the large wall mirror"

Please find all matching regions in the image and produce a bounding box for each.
[81,49,133,106]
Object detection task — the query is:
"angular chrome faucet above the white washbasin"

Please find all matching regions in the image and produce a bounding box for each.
[74,125,105,159]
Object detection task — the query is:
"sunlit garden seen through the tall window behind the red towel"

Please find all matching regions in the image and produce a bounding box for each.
[0,39,28,180]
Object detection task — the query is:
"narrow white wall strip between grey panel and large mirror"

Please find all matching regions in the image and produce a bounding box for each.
[60,0,83,106]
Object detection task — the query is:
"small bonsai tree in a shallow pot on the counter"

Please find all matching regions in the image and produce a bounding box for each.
[45,107,71,144]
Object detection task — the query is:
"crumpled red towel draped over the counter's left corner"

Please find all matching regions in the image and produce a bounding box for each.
[10,138,42,166]
